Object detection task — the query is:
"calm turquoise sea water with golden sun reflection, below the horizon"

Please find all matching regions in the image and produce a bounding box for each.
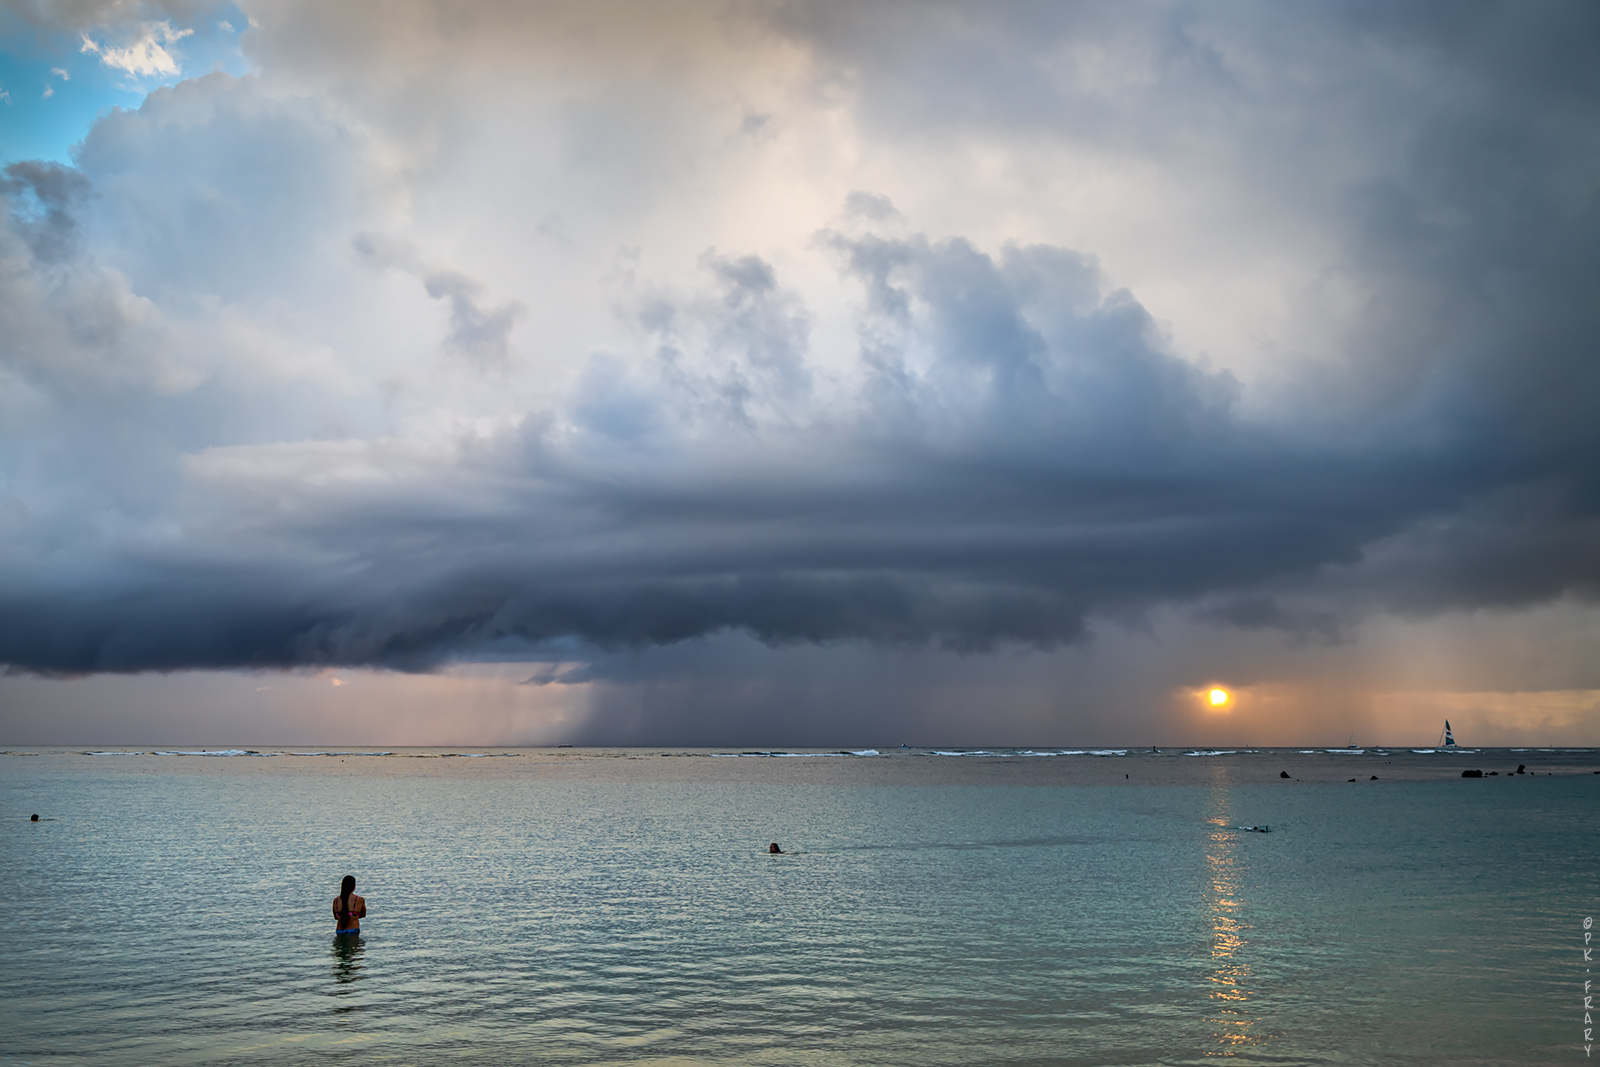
[0,755,1600,1067]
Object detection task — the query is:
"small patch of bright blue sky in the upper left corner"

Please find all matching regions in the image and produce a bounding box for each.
[0,3,250,166]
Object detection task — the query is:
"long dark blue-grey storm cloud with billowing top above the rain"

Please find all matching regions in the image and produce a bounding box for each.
[0,222,1594,672]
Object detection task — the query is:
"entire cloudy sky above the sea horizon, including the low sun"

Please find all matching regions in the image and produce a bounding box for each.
[0,0,1600,747]
